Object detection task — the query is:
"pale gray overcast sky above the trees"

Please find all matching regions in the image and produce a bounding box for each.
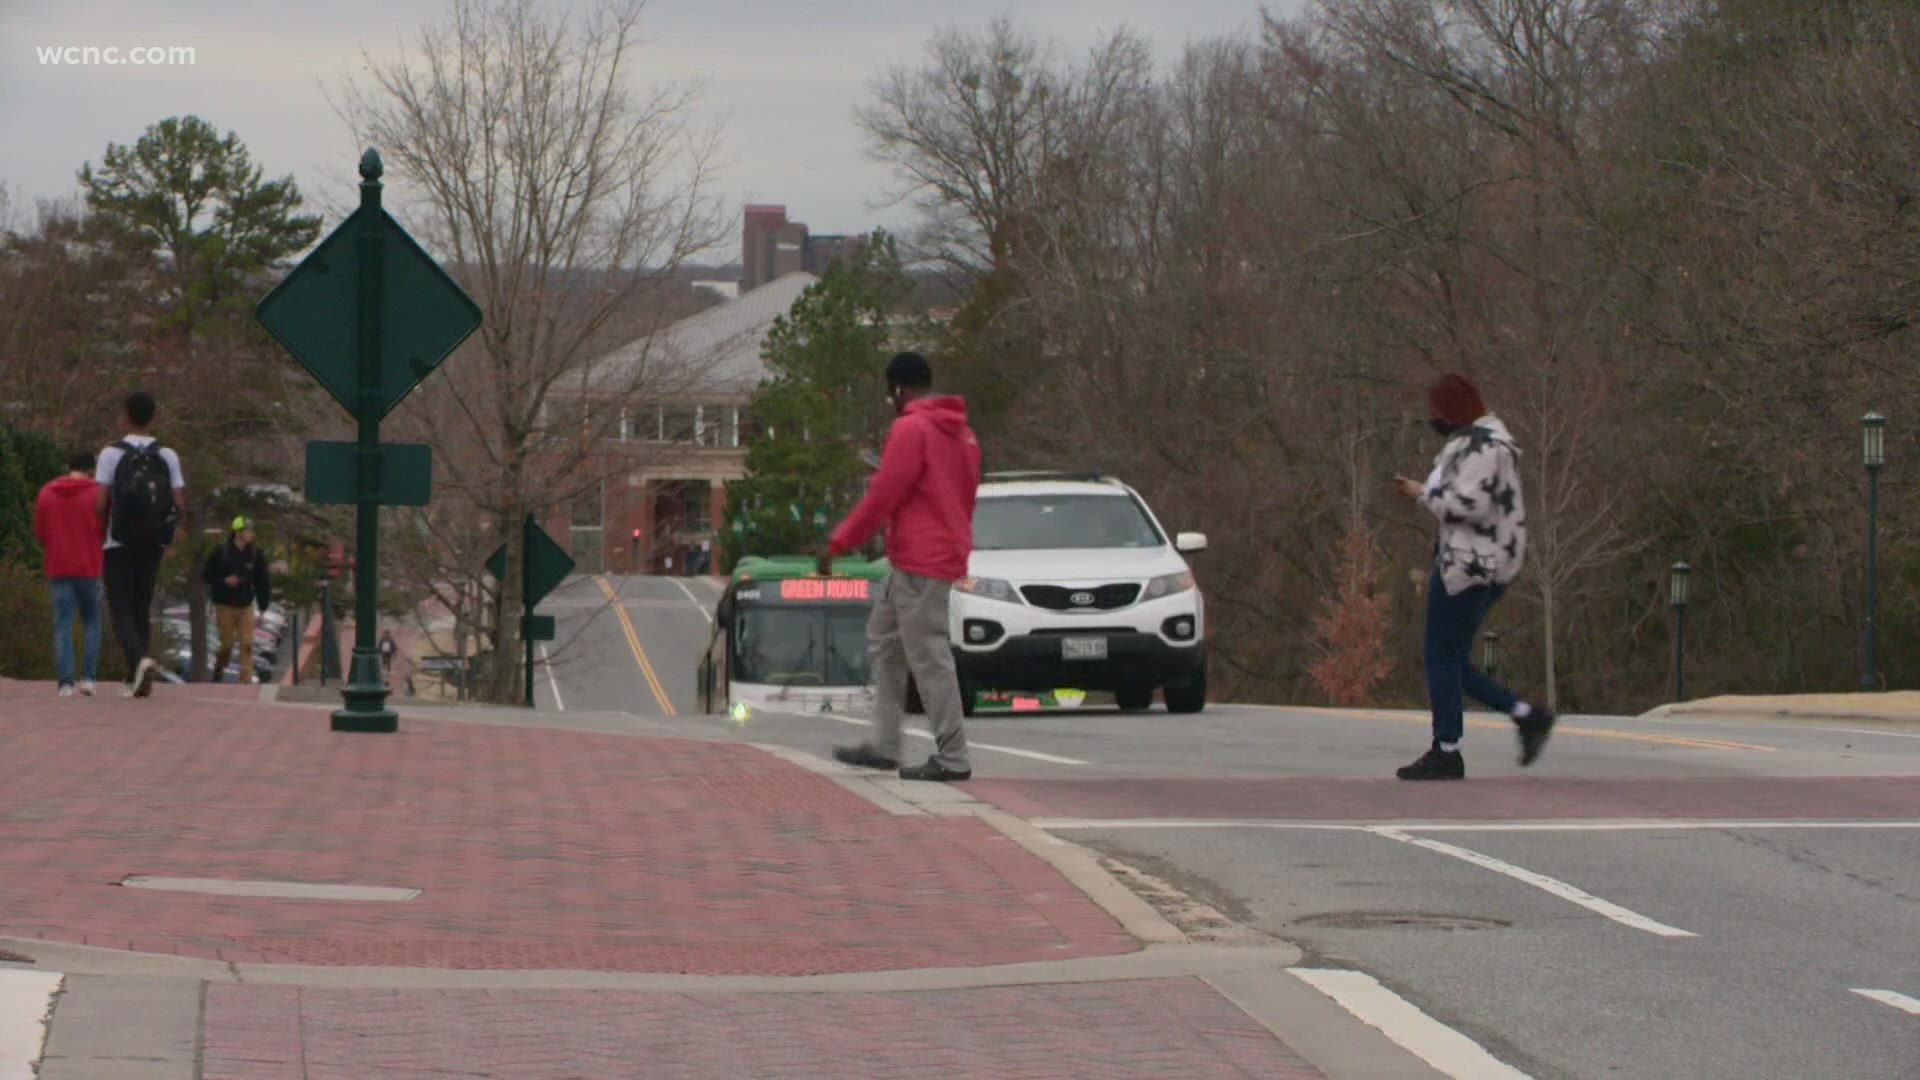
[0,0,1300,251]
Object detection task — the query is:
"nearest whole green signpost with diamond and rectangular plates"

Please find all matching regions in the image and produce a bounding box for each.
[253,150,480,732]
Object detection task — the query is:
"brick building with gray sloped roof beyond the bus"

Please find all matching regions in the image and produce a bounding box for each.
[547,271,818,575]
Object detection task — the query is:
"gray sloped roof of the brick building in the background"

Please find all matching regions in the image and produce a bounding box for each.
[595,273,820,394]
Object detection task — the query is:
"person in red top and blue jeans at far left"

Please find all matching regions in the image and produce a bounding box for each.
[33,450,106,698]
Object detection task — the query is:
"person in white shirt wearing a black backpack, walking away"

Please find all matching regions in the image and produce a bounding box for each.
[94,390,186,698]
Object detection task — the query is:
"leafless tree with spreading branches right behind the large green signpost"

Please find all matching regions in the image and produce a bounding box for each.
[340,0,726,700]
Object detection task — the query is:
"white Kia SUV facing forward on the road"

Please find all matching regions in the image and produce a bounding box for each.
[948,473,1206,713]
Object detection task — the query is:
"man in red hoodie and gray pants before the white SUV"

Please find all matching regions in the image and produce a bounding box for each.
[820,352,979,780]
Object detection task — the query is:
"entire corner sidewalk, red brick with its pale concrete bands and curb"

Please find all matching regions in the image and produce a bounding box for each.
[0,682,1436,1080]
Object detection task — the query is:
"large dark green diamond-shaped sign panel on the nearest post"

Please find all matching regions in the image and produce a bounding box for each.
[255,209,480,417]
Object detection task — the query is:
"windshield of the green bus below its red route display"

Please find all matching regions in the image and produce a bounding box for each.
[732,603,868,686]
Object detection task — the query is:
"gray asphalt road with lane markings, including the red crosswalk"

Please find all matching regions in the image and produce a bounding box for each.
[541,578,1920,1080]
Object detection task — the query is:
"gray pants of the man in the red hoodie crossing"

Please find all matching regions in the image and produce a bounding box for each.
[866,571,973,773]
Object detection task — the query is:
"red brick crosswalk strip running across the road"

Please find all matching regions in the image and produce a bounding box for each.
[968,776,1920,821]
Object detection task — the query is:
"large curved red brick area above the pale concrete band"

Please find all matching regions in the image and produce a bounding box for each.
[0,682,1137,974]
